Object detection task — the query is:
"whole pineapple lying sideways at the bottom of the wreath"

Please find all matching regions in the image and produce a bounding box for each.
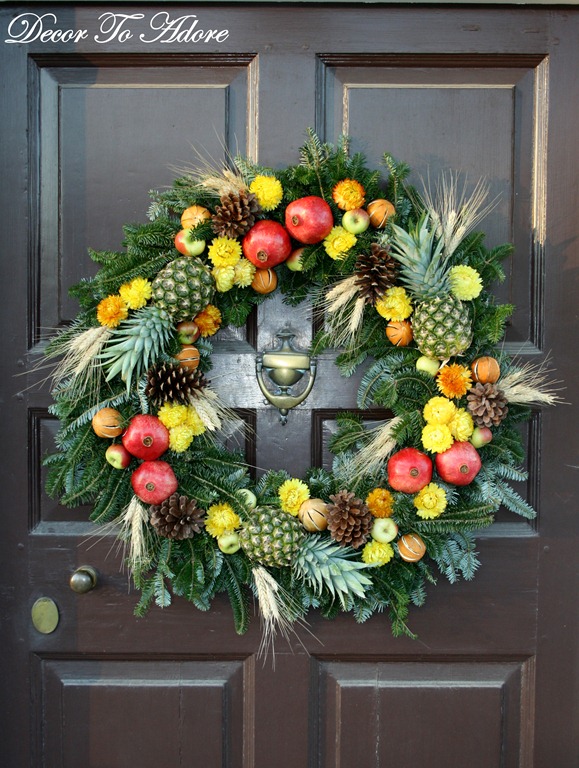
[240,507,372,610]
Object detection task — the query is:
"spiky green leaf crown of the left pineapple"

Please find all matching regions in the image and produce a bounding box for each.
[99,306,174,392]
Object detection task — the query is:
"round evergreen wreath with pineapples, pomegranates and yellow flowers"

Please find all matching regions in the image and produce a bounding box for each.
[45,131,557,644]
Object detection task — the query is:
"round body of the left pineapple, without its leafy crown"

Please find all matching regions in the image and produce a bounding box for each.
[153,256,215,322]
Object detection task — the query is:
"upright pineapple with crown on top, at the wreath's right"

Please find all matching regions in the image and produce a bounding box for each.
[391,214,472,360]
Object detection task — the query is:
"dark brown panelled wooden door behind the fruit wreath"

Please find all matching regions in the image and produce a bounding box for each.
[0,3,579,768]
